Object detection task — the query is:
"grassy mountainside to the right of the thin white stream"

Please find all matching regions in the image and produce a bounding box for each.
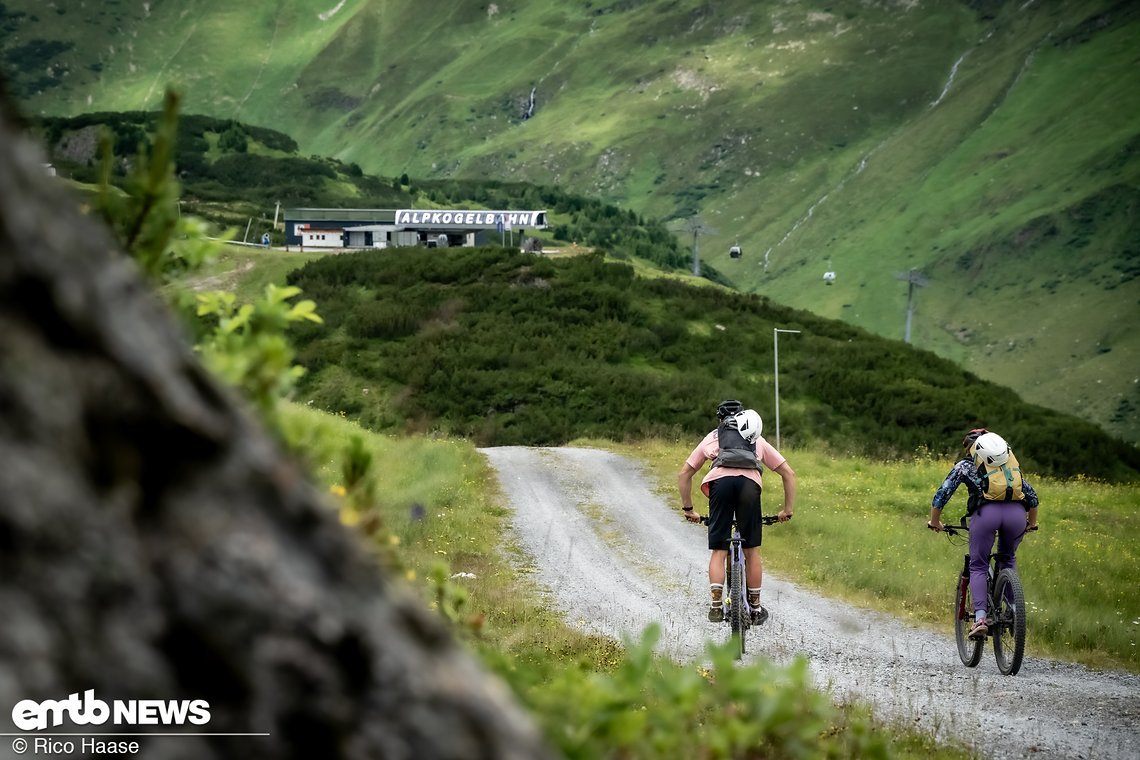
[725,4,1140,432]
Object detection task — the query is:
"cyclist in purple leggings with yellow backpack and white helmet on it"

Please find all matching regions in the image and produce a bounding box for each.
[927,427,1037,639]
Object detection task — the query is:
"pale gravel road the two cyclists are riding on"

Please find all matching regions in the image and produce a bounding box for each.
[481,447,1140,760]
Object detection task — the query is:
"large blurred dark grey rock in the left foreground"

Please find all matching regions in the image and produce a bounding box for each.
[0,84,548,760]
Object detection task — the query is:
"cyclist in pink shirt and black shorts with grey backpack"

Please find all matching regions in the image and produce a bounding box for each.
[677,400,796,624]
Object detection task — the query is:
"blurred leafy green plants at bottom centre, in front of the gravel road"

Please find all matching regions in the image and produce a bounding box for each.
[528,624,888,760]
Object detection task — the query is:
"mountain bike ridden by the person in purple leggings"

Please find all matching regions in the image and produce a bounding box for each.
[943,515,1036,676]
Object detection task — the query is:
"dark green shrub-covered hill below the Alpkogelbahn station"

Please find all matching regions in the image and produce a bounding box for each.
[290,247,1140,480]
